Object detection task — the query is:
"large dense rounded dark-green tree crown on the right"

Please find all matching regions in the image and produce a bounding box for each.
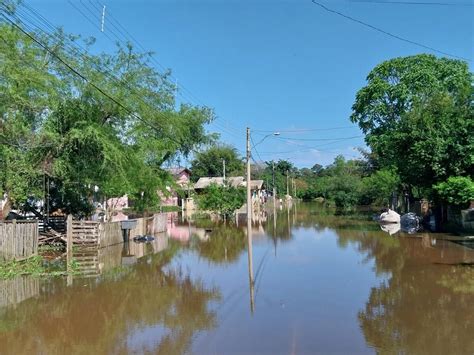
[351,55,474,196]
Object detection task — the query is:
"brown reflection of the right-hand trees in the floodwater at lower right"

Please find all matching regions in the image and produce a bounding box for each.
[278,204,474,354]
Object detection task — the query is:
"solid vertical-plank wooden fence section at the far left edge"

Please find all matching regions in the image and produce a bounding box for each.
[0,220,39,261]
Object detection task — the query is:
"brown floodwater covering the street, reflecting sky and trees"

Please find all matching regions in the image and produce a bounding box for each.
[0,203,474,354]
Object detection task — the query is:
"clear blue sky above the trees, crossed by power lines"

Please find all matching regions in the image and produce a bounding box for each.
[26,0,474,167]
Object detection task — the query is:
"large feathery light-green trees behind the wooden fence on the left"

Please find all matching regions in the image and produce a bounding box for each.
[0,16,215,216]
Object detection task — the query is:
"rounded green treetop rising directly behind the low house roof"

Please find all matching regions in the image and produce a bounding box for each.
[191,144,244,181]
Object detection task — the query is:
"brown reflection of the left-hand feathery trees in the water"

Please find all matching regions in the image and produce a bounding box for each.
[0,246,221,354]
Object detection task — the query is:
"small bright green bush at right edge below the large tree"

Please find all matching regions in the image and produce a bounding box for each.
[434,176,474,205]
